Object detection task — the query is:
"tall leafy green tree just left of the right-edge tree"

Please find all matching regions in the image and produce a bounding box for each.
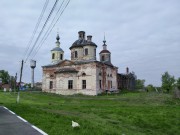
[161,72,175,93]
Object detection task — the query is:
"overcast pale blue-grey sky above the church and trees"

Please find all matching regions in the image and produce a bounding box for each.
[0,0,180,86]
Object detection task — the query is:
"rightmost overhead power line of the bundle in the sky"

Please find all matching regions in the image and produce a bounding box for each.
[33,0,70,57]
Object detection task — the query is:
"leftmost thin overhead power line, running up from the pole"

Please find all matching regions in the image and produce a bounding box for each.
[23,0,49,57]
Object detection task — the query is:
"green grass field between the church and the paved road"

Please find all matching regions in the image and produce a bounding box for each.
[0,92,180,135]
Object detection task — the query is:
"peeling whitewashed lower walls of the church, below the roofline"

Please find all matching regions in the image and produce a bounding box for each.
[42,62,117,95]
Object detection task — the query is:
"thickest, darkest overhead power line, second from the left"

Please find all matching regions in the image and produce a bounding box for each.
[25,0,59,62]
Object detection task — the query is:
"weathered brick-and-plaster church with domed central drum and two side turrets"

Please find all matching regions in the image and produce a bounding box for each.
[42,31,118,95]
